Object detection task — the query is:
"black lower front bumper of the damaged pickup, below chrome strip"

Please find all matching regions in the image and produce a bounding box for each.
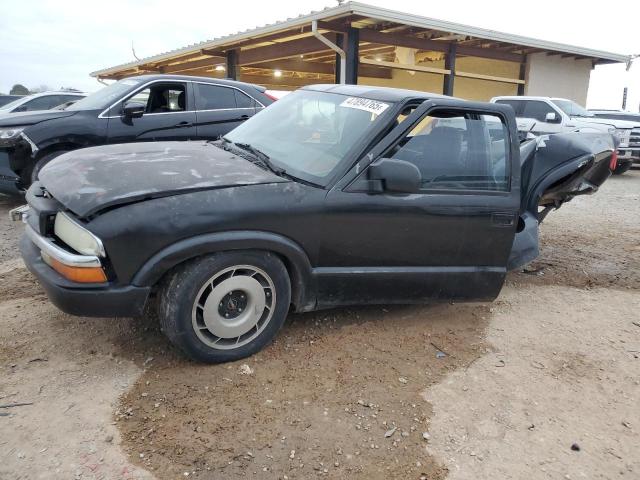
[20,235,151,317]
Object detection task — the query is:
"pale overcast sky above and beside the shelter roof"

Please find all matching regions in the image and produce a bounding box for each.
[0,0,640,111]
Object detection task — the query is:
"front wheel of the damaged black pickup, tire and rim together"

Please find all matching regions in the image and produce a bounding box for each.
[158,250,291,363]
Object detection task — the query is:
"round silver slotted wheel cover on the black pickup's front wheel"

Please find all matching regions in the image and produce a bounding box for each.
[191,265,276,350]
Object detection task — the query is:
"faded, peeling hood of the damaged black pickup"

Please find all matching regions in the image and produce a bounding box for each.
[39,142,289,218]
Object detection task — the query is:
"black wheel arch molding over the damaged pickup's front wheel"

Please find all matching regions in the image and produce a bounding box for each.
[132,230,317,311]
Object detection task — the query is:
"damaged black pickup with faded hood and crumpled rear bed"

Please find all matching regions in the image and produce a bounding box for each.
[13,85,615,362]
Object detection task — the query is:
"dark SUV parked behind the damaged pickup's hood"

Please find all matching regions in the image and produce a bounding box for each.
[0,75,274,194]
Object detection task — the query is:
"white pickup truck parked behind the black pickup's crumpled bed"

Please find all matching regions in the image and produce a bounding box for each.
[491,96,640,175]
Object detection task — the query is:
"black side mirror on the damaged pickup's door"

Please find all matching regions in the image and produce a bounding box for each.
[368,158,422,193]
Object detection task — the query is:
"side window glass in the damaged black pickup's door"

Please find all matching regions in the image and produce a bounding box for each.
[384,111,510,191]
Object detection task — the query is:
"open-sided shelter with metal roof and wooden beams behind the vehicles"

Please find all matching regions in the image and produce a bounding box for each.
[91,2,630,104]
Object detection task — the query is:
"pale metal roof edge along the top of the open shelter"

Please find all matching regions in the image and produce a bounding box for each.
[91,2,631,77]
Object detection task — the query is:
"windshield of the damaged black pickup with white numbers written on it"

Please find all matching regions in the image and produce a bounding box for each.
[224,90,391,185]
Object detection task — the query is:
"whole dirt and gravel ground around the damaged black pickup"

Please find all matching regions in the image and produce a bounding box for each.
[0,170,640,480]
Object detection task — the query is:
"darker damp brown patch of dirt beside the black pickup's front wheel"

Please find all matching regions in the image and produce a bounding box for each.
[115,304,490,480]
